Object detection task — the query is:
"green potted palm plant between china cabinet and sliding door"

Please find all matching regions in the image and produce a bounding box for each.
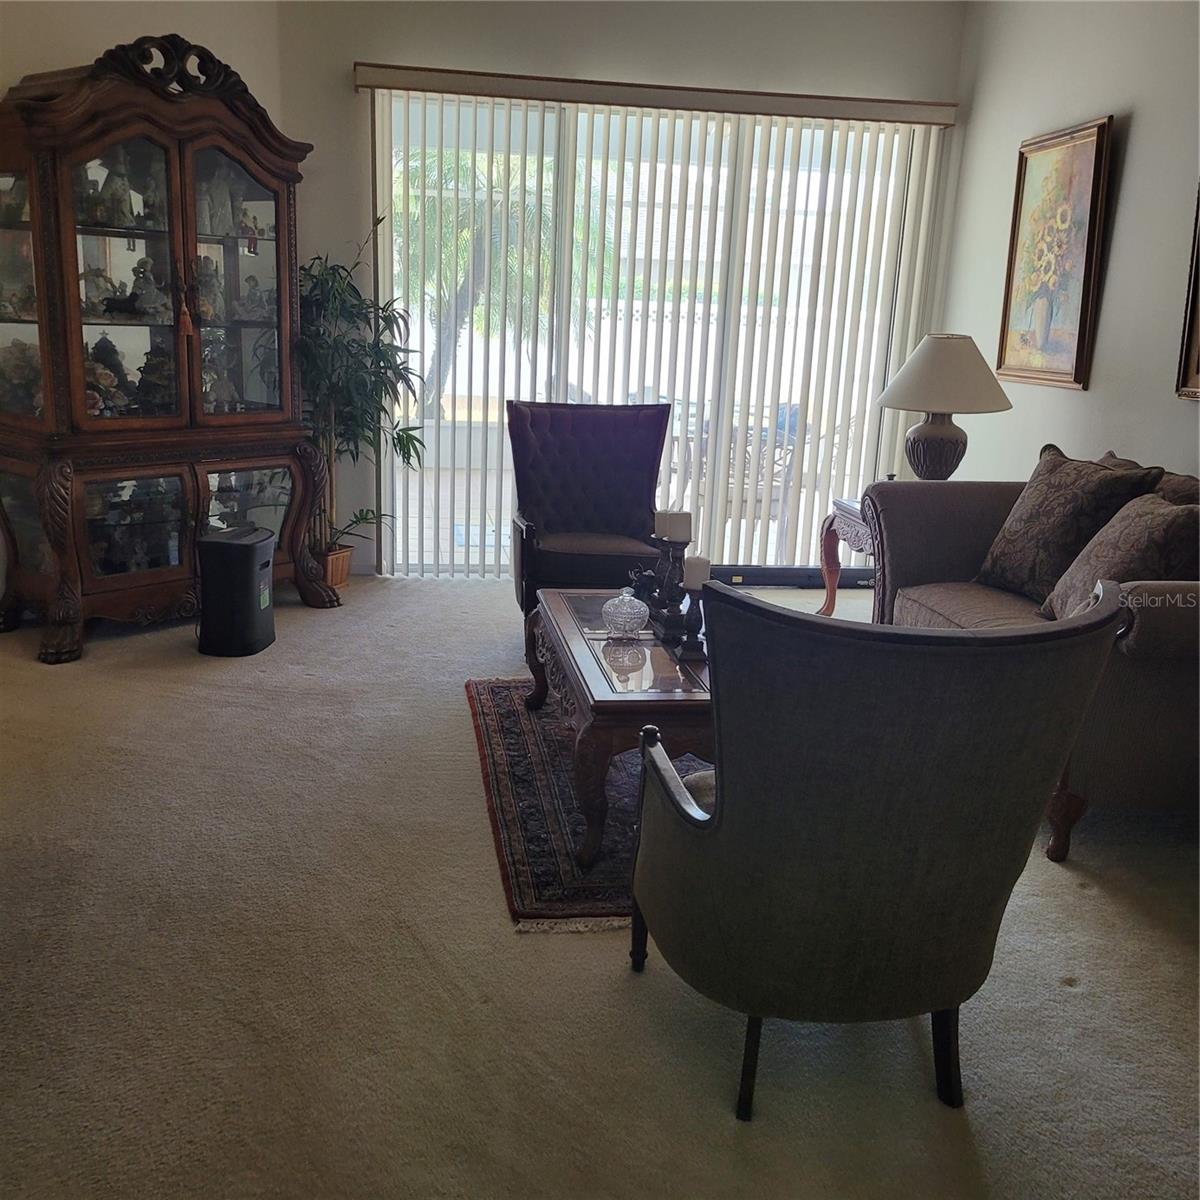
[296,217,425,587]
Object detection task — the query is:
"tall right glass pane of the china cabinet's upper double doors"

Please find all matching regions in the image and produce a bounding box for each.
[191,146,282,420]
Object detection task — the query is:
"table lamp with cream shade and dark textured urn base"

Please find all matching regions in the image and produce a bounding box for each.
[880,334,1013,479]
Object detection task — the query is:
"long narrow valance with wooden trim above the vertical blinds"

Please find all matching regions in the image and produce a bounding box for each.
[354,62,958,127]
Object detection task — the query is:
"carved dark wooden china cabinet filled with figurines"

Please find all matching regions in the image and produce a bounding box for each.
[0,35,340,662]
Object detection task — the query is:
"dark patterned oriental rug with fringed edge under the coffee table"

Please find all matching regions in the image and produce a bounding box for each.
[467,678,707,932]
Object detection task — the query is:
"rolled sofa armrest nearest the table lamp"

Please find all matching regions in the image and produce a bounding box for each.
[863,480,1025,625]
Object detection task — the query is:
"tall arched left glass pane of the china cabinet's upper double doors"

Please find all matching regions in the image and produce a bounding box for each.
[71,137,182,422]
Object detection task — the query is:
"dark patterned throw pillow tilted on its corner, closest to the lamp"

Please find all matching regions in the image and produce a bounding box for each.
[977,445,1163,602]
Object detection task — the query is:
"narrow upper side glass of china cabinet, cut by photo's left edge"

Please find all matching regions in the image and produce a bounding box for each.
[0,170,43,420]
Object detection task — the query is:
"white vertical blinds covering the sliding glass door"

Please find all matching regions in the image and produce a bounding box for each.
[376,91,943,575]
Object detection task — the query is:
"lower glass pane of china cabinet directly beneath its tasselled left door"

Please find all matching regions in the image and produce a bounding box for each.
[83,474,191,583]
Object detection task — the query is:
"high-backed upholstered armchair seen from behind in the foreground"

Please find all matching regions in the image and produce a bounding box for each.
[630,583,1121,1120]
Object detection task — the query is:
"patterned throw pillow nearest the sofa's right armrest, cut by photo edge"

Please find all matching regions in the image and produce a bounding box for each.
[1038,493,1200,617]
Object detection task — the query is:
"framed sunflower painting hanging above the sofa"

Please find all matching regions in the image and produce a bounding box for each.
[996,116,1112,388]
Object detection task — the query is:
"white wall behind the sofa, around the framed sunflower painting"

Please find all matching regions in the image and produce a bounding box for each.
[943,2,1200,479]
